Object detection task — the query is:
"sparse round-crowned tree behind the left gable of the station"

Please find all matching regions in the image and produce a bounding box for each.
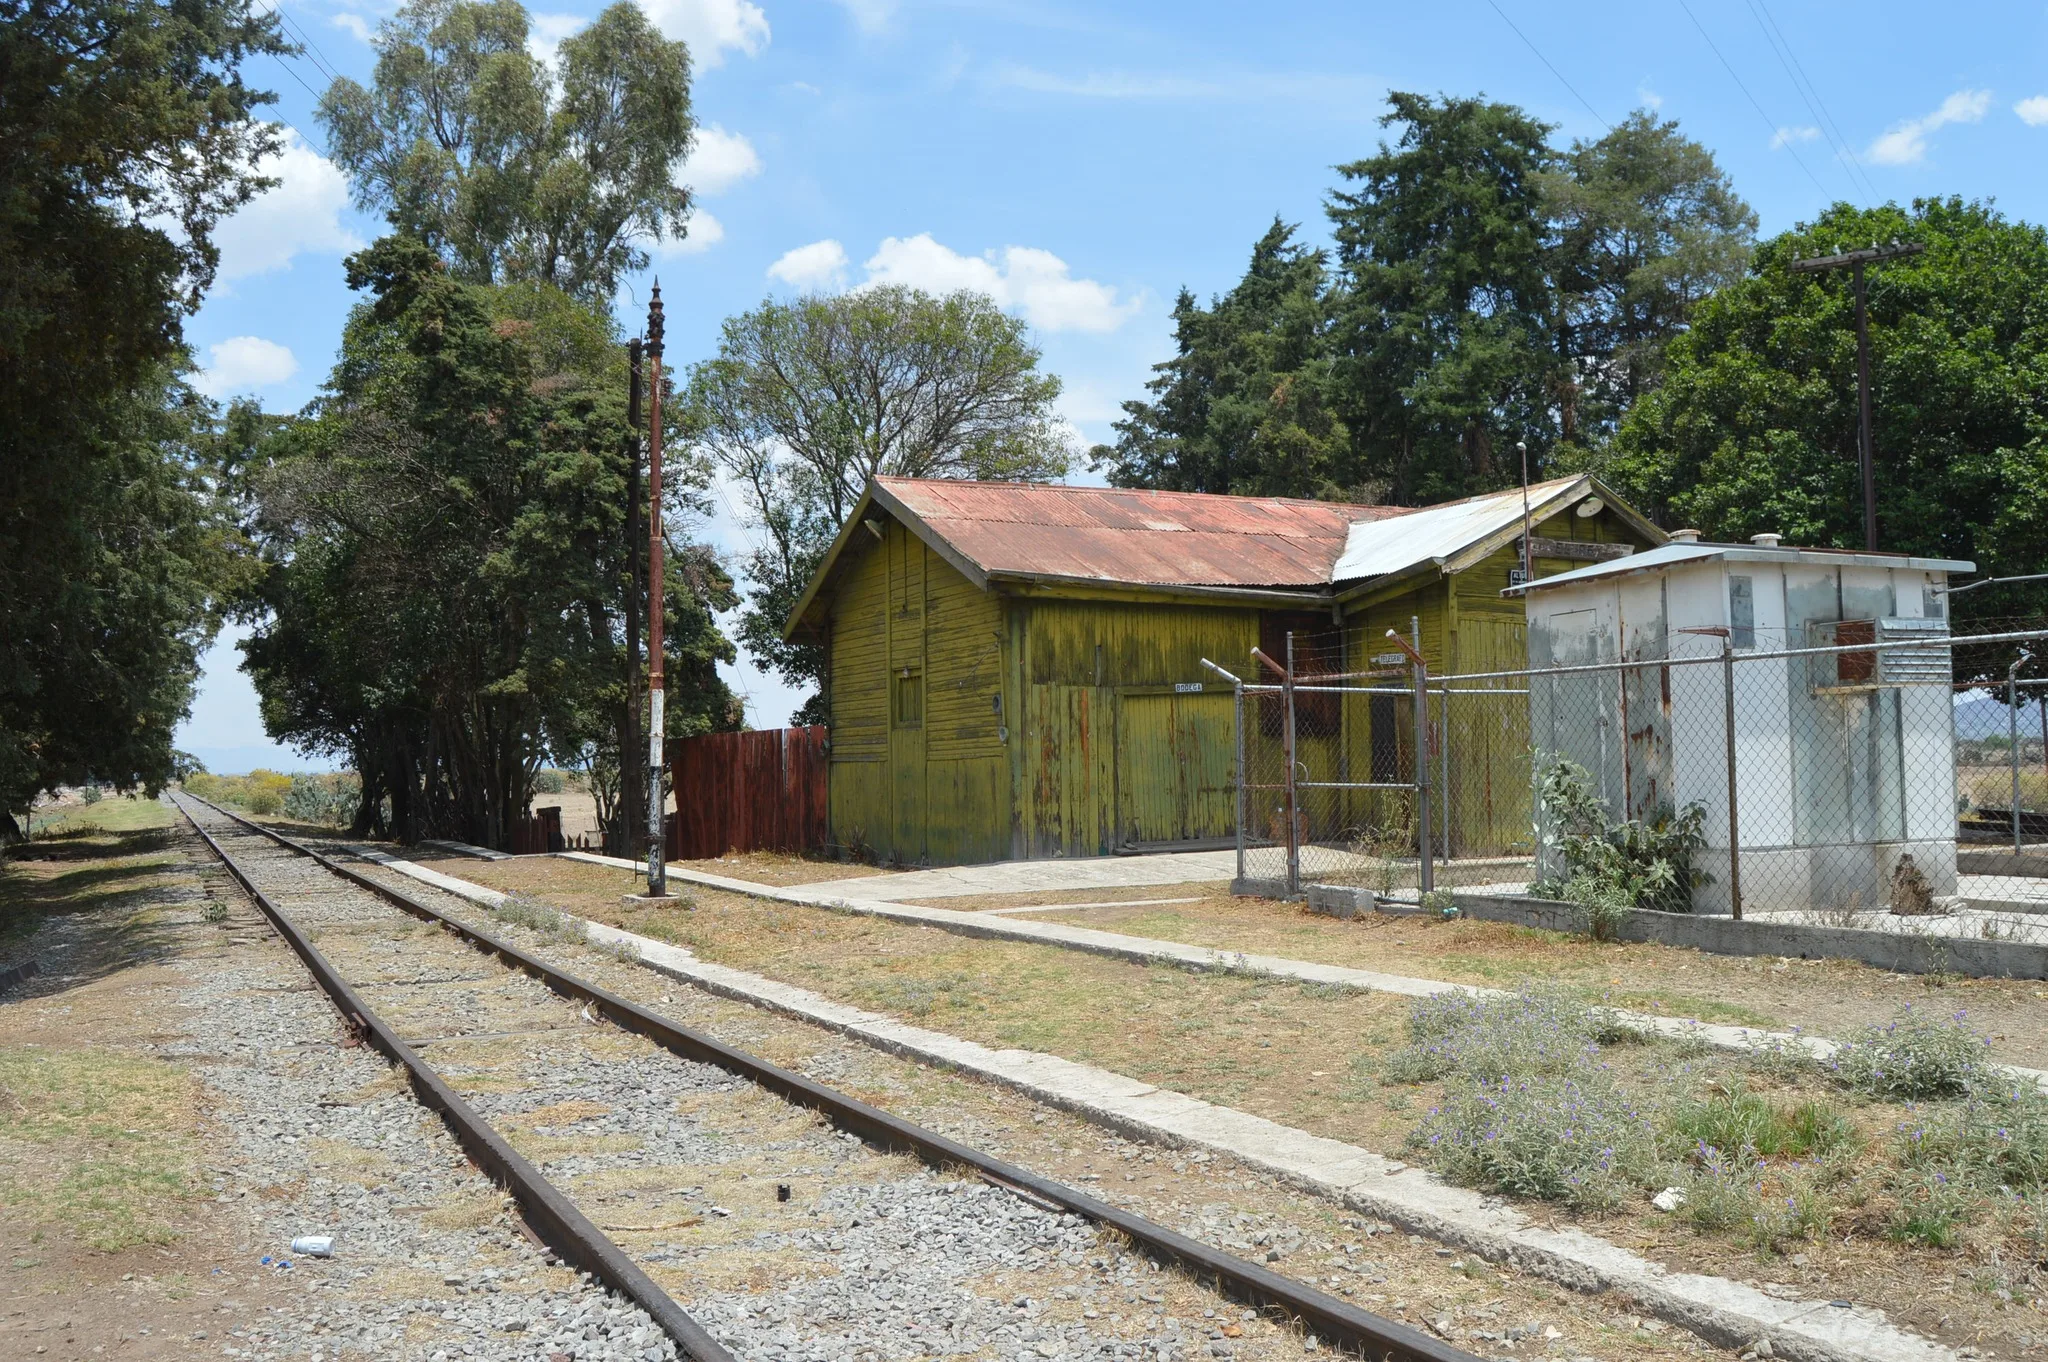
[682,287,1067,723]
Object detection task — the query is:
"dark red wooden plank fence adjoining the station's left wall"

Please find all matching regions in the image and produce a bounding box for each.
[668,725,825,860]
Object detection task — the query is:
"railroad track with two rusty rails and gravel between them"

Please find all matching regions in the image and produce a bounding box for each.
[176,795,1475,1362]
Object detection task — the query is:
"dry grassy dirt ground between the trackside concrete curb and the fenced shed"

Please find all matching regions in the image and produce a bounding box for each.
[399,860,2048,1356]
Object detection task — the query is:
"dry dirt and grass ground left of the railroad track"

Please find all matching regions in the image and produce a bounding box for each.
[0,801,289,1358]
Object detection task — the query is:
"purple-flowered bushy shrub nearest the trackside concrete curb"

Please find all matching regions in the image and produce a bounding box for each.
[1409,1065,1665,1210]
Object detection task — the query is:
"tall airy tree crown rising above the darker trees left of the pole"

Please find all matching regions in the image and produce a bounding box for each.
[319,0,692,301]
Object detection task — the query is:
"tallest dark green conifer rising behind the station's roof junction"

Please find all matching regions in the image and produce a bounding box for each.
[1329,92,1559,504]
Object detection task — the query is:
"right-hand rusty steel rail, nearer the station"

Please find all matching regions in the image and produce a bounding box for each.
[186,795,1481,1362]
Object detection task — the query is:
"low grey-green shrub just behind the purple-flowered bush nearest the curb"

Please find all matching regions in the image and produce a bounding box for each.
[1384,989,1634,1083]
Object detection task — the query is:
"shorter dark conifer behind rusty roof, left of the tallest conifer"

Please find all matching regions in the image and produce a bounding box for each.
[1090,219,1370,498]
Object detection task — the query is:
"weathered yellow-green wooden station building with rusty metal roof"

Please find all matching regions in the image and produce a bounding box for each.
[784,475,1665,864]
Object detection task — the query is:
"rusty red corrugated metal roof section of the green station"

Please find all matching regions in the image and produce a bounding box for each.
[874,477,1411,588]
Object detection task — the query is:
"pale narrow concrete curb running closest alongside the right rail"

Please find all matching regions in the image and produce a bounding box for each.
[367,852,1958,1362]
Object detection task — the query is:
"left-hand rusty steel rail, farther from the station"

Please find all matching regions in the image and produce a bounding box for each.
[178,795,737,1362]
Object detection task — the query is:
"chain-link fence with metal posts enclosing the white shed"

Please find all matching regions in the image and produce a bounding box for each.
[1239,619,2048,942]
